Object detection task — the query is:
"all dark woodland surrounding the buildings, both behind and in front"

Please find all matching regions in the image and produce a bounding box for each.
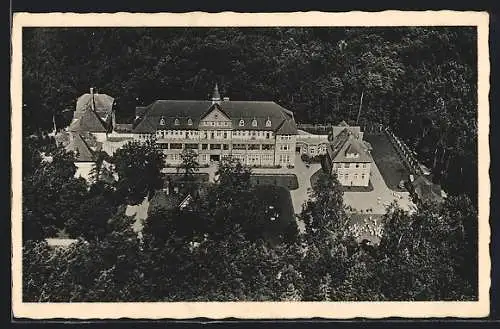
[23,27,478,302]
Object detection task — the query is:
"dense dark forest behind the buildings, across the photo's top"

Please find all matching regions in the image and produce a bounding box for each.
[22,27,477,204]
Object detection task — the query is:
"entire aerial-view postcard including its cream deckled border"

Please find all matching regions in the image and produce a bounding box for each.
[12,12,489,318]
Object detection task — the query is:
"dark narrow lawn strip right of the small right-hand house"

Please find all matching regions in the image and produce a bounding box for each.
[364,134,410,192]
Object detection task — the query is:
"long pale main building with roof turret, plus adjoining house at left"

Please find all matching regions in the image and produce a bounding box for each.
[69,85,297,167]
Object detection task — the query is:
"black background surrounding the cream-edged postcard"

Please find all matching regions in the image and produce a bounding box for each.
[7,0,500,328]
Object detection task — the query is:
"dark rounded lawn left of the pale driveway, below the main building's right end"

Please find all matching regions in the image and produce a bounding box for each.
[250,185,297,243]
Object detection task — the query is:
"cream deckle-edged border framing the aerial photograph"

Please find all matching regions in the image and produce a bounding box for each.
[11,11,491,319]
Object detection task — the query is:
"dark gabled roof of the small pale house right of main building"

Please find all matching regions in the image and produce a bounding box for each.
[327,128,373,162]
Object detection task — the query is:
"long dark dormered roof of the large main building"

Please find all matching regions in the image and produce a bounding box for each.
[134,100,297,134]
